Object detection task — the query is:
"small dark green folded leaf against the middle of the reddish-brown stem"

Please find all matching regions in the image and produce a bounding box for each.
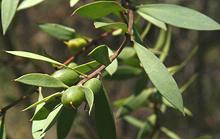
[89,45,111,66]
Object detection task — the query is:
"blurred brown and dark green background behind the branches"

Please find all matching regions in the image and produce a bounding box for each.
[0,0,220,139]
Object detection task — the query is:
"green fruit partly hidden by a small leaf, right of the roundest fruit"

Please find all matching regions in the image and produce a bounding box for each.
[84,78,102,95]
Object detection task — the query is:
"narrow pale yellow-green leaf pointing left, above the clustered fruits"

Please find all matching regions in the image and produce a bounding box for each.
[6,51,65,66]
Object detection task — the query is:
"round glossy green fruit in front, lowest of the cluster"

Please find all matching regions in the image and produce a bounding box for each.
[61,86,85,108]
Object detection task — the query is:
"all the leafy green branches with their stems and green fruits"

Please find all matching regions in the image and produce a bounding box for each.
[0,0,220,139]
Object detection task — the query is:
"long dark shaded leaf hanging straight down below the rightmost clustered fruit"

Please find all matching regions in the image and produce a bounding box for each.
[94,87,116,139]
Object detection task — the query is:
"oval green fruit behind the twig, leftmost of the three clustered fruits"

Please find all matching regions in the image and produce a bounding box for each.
[52,63,80,86]
